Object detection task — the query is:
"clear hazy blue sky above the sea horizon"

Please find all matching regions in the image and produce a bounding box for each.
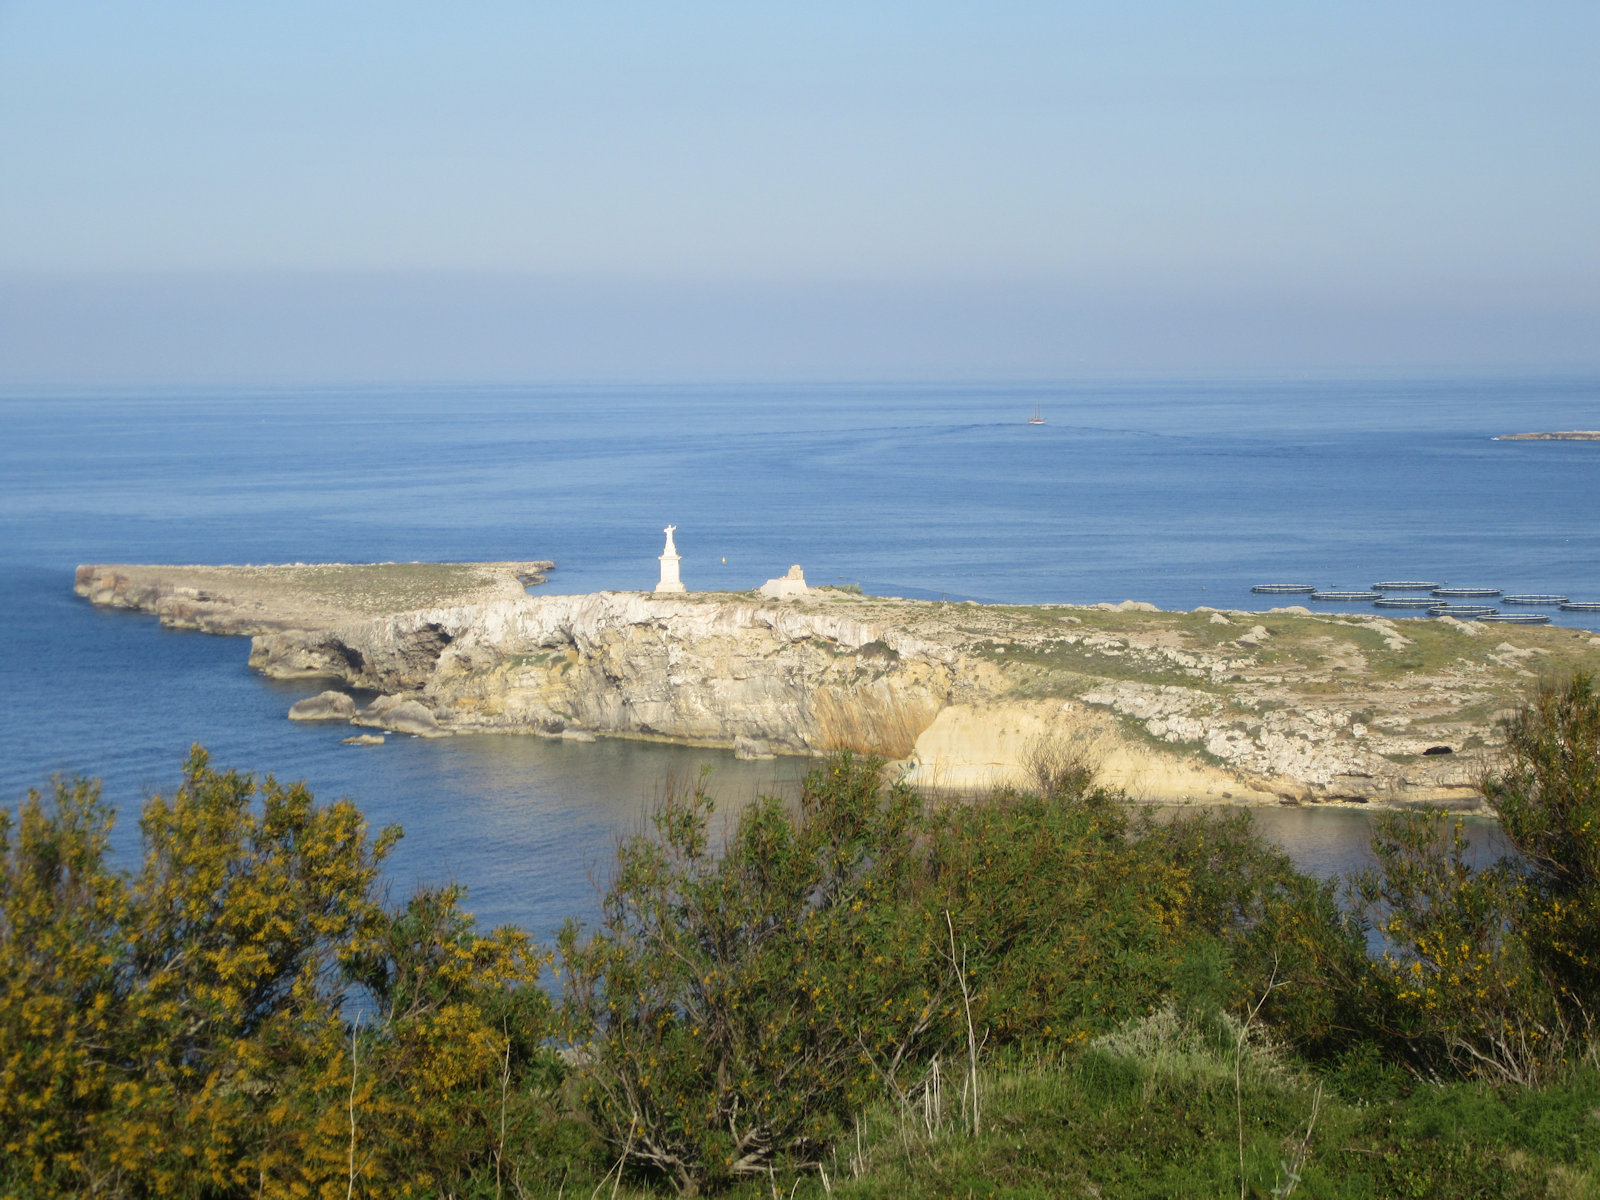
[0,0,1600,384]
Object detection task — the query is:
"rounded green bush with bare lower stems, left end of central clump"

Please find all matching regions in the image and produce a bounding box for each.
[560,754,947,1194]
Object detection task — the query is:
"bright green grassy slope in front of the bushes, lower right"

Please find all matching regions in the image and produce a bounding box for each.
[694,1010,1600,1200]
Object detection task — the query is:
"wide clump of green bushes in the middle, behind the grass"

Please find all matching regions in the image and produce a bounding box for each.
[560,754,1360,1192]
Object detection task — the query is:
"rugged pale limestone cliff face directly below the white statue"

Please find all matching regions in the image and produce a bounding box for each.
[250,592,955,758]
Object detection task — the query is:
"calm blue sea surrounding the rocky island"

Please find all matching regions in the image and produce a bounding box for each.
[0,379,1580,934]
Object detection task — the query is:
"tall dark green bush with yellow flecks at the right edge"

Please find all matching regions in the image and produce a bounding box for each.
[1354,674,1600,1085]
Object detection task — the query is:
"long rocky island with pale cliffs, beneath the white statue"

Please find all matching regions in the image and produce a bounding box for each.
[75,562,1600,806]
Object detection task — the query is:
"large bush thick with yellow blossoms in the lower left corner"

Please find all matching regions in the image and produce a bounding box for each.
[0,747,552,1197]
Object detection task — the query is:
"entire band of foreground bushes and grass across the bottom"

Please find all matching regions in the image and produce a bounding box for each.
[9,677,1600,1197]
